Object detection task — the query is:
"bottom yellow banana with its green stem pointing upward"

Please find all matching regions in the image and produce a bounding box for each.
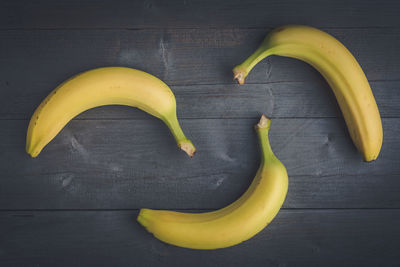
[137,115,288,249]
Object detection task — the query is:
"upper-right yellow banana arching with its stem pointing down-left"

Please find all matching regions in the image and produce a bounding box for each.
[233,25,383,161]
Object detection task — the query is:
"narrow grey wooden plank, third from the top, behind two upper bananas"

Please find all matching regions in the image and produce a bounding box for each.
[0,80,400,120]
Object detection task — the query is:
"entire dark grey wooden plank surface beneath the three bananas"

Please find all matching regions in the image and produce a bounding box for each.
[0,0,400,266]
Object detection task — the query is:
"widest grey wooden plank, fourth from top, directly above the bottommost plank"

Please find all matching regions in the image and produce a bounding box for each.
[0,118,400,209]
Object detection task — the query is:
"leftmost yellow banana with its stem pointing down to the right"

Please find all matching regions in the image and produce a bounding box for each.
[26,67,196,157]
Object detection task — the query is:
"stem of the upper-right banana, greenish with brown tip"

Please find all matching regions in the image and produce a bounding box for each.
[233,43,272,84]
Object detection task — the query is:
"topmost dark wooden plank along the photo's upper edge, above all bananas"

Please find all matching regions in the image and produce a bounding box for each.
[0,0,400,29]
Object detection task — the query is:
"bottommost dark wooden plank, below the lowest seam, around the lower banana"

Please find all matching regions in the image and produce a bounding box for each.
[0,210,400,266]
